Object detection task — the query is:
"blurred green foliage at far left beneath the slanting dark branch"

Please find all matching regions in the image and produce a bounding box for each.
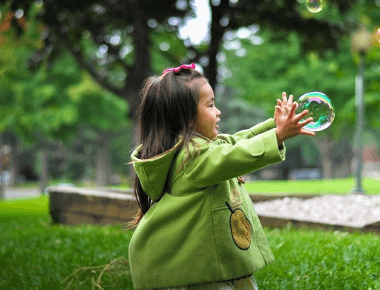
[0,24,128,143]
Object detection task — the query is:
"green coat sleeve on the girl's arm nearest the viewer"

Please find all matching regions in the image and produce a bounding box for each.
[182,129,285,188]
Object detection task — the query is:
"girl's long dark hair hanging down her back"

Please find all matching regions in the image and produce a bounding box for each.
[130,69,208,226]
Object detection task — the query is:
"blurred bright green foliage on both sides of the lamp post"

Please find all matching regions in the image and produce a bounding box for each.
[222,0,380,139]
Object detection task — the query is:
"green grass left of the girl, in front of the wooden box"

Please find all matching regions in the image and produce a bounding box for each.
[0,197,133,290]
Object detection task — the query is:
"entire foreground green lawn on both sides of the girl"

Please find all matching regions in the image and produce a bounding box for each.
[0,197,380,290]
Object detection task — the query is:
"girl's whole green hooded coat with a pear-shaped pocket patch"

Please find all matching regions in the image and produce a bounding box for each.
[129,119,285,289]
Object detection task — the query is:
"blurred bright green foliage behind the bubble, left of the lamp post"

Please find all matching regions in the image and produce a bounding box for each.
[225,33,356,133]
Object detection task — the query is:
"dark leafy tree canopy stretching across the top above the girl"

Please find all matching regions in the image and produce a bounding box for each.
[5,0,356,119]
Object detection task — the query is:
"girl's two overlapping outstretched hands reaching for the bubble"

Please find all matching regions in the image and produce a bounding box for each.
[274,93,315,145]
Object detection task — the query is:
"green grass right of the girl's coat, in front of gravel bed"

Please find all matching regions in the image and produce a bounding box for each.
[255,227,380,290]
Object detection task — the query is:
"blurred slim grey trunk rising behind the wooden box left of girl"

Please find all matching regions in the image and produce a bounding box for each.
[96,135,111,187]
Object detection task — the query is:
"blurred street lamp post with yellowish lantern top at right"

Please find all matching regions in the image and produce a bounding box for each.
[351,24,372,194]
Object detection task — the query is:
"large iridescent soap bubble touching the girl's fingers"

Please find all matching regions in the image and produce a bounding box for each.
[296,92,335,131]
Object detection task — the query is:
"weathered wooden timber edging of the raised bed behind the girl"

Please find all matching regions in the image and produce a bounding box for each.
[47,187,380,233]
